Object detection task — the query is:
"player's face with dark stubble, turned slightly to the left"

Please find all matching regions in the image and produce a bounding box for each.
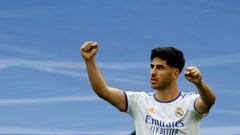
[150,57,177,90]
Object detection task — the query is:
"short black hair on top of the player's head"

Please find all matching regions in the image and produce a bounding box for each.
[151,47,185,72]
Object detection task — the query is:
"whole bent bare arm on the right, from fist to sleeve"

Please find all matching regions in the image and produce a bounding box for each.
[184,66,216,114]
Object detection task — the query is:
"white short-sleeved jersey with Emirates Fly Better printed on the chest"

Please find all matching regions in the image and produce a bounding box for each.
[124,91,202,135]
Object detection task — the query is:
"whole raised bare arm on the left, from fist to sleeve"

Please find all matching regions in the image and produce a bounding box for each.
[80,41,126,111]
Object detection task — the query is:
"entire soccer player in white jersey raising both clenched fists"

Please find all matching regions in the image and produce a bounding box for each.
[80,41,215,135]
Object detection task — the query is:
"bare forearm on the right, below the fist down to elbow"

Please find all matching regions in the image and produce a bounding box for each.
[195,80,216,109]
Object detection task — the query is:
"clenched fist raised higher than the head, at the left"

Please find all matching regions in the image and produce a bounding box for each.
[80,41,98,60]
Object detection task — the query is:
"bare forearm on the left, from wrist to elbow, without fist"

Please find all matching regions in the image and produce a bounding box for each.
[85,59,108,97]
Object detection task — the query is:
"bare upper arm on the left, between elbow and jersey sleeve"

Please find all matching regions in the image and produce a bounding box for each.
[101,87,127,111]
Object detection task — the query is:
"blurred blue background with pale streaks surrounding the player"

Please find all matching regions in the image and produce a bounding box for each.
[0,0,240,135]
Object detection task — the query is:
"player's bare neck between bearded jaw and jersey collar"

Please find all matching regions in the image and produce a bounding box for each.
[155,83,179,101]
